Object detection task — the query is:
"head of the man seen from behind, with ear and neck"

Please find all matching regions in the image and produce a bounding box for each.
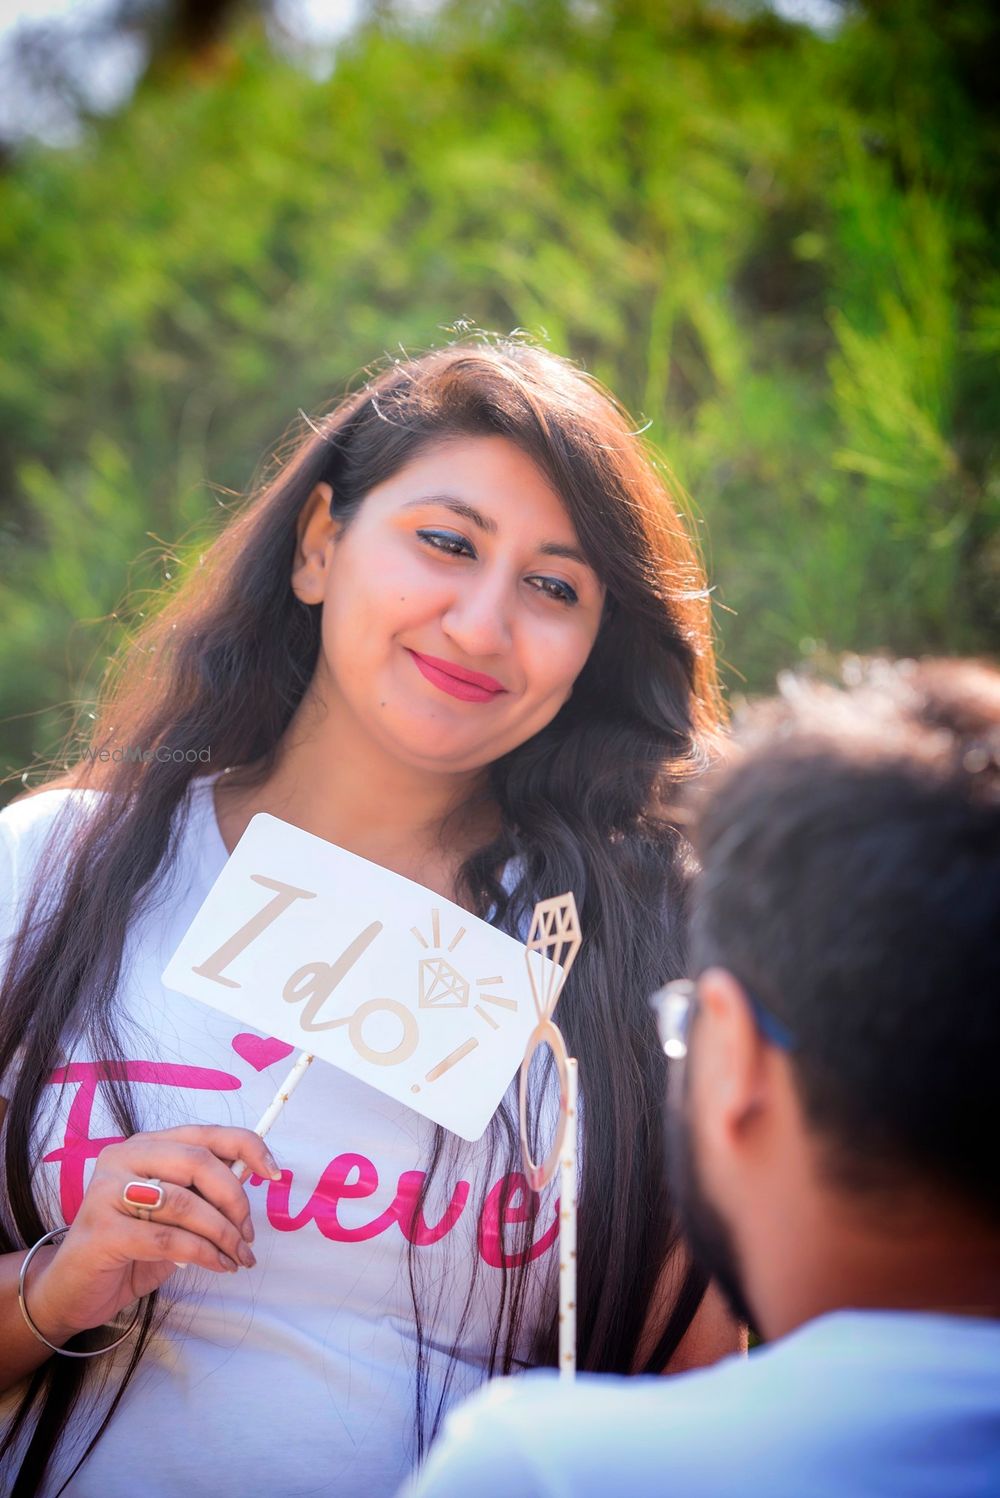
[668,661,1000,1335]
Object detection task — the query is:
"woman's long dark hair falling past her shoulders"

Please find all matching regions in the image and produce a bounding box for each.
[0,336,722,1498]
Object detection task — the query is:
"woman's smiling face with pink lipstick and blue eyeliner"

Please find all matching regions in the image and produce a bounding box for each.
[293,436,605,771]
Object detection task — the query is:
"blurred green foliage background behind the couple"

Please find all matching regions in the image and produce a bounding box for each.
[0,0,1000,801]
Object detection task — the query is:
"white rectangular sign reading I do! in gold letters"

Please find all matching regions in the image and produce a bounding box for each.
[162,812,558,1140]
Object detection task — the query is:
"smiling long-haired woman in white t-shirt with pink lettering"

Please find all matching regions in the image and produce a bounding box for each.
[0,340,740,1495]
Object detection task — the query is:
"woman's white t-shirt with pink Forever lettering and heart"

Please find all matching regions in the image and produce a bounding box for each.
[0,773,557,1498]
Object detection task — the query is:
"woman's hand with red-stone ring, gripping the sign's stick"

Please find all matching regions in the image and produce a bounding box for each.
[25,1124,280,1345]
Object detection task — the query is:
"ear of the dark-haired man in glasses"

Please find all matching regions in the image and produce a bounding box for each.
[689,968,769,1149]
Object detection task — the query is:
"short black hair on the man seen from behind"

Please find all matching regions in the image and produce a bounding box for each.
[692,658,1000,1221]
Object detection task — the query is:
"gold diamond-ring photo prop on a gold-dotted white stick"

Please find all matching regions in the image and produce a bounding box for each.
[518,891,582,1378]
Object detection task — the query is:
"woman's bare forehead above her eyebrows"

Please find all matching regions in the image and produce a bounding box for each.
[362,436,575,539]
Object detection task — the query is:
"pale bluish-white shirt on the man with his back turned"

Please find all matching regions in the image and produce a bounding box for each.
[400,1311,1000,1498]
